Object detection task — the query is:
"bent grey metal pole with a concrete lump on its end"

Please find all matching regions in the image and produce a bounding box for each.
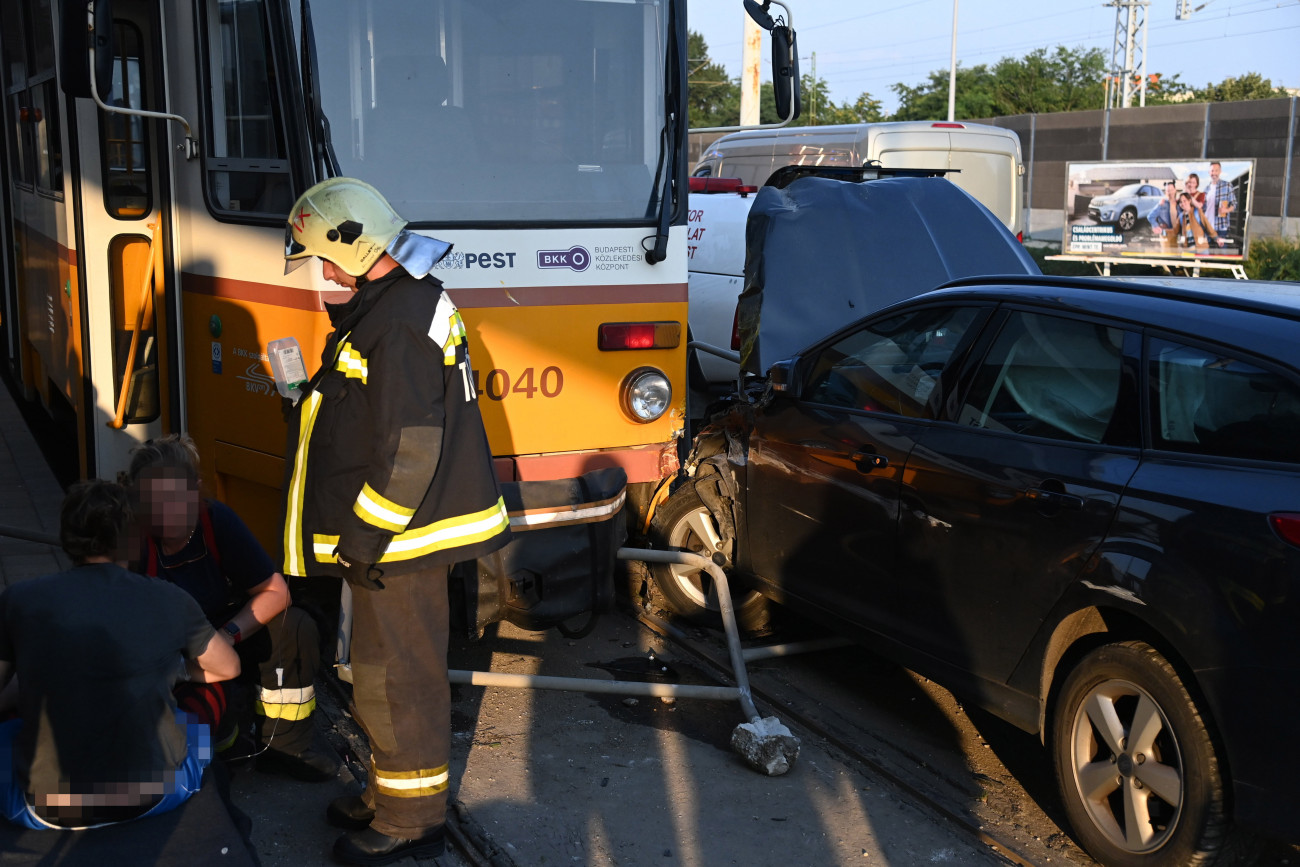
[618,547,800,776]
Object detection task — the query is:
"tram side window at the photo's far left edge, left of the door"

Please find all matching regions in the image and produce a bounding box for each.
[3,0,64,196]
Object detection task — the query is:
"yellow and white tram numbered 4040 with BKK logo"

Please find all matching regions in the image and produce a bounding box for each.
[0,0,686,551]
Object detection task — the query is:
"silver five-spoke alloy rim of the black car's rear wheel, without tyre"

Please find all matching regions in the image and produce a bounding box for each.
[1070,680,1186,854]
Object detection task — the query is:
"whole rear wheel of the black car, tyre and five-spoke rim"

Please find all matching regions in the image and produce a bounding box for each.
[1053,641,1229,867]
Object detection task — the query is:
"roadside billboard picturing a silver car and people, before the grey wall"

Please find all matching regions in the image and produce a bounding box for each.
[1061,160,1255,261]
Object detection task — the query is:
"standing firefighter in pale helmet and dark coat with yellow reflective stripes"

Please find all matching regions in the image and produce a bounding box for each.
[283,178,510,864]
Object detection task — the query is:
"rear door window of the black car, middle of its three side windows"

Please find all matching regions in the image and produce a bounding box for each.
[959,311,1125,442]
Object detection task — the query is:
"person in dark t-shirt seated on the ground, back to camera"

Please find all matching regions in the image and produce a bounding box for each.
[0,480,239,829]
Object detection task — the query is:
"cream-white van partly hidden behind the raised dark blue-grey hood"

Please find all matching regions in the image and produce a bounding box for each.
[692,121,1024,238]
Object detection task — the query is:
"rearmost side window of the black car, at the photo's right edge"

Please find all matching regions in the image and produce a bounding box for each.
[1148,338,1300,463]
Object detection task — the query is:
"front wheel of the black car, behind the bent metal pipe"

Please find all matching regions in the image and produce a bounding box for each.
[650,485,770,633]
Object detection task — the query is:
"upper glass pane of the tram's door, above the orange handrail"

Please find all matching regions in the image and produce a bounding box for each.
[99,21,153,220]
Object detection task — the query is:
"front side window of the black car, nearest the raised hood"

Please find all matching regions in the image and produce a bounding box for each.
[802,307,982,419]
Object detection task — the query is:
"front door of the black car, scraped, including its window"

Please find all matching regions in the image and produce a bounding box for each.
[745,305,991,629]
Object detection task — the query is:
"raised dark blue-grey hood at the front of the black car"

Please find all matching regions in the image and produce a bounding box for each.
[738,177,1041,374]
